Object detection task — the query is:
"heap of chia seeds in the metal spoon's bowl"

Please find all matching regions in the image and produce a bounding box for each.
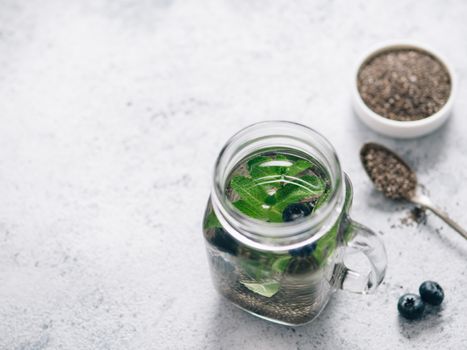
[360,143,417,199]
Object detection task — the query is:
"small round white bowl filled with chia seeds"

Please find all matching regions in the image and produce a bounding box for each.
[353,43,455,138]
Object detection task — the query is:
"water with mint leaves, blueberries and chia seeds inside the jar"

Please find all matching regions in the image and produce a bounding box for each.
[203,149,350,324]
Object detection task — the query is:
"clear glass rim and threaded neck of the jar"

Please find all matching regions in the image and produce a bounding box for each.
[212,120,344,244]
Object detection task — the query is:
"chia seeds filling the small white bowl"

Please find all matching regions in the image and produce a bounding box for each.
[357,49,451,121]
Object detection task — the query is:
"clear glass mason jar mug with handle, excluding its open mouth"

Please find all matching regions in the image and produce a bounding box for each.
[203,121,386,325]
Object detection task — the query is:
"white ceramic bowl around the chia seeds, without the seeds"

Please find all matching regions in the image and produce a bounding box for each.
[352,41,457,139]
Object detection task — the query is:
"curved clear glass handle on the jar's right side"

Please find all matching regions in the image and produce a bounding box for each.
[340,219,387,294]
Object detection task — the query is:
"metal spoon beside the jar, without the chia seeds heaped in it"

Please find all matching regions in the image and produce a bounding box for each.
[360,142,467,239]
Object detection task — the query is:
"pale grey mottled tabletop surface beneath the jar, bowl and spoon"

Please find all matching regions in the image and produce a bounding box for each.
[0,0,467,350]
